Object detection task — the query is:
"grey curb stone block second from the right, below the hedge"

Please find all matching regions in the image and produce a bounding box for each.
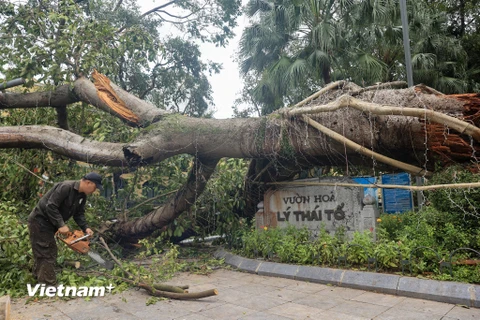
[339,270,400,294]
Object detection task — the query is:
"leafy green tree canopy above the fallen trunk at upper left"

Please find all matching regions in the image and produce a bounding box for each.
[0,0,240,116]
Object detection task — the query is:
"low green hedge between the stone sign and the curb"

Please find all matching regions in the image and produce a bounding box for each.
[237,207,480,283]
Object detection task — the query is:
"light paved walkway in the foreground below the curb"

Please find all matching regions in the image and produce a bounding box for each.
[12,269,480,320]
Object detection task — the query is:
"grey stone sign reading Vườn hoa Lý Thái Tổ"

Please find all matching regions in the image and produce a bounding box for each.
[257,177,378,235]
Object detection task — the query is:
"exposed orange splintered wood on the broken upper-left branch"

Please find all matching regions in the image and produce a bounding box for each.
[92,70,139,124]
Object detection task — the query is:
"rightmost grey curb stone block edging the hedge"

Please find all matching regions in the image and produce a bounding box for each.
[397,277,480,308]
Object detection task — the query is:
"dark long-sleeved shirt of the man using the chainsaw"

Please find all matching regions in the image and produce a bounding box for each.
[29,181,88,232]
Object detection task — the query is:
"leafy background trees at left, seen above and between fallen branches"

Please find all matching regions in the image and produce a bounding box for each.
[0,0,240,240]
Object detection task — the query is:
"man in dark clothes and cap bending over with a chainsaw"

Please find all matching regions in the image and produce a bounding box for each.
[28,172,102,286]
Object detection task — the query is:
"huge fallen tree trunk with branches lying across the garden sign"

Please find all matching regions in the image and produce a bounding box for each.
[0,74,480,238]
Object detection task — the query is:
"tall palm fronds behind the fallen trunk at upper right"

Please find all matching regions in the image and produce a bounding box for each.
[236,1,478,116]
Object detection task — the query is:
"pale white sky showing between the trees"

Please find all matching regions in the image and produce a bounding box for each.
[137,0,247,119]
